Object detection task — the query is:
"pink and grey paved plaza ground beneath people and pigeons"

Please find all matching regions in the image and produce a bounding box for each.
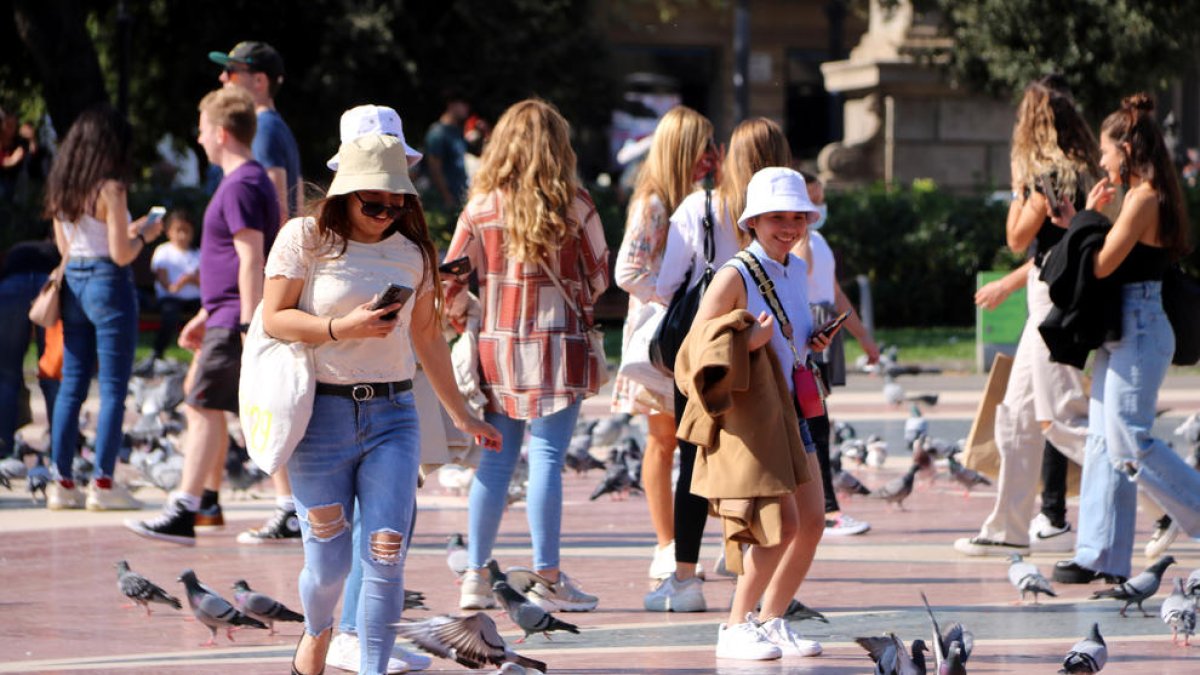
[0,376,1200,675]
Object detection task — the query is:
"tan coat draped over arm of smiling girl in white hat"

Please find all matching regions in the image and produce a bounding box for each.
[676,310,811,573]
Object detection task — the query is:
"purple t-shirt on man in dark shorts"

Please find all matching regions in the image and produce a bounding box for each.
[200,160,280,330]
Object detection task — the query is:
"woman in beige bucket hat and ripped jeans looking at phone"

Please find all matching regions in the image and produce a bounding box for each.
[263,128,499,674]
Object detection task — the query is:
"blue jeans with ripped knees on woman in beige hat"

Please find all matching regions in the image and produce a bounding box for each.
[288,392,420,673]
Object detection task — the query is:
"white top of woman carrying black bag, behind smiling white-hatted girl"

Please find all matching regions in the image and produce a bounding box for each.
[655,184,740,297]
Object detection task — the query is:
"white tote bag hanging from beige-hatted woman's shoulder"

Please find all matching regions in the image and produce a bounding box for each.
[238,304,317,473]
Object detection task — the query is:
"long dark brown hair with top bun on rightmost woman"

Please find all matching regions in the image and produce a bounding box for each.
[1100,92,1190,259]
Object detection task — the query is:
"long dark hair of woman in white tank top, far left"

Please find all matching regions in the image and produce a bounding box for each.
[46,103,133,222]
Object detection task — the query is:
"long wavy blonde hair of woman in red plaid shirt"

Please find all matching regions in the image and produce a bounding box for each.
[470,98,578,263]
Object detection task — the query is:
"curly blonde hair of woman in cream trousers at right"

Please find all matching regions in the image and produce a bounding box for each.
[1012,74,1100,201]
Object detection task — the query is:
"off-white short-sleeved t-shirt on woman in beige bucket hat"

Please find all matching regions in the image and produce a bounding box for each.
[266,219,433,384]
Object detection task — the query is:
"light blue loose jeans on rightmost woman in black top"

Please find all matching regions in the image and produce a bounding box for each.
[1074,281,1200,577]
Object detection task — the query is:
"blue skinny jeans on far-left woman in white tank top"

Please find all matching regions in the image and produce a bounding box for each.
[50,258,138,478]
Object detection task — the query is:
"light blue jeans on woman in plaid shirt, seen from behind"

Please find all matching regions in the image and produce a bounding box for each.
[467,401,581,569]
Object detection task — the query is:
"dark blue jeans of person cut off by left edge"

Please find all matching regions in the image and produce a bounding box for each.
[0,271,59,456]
